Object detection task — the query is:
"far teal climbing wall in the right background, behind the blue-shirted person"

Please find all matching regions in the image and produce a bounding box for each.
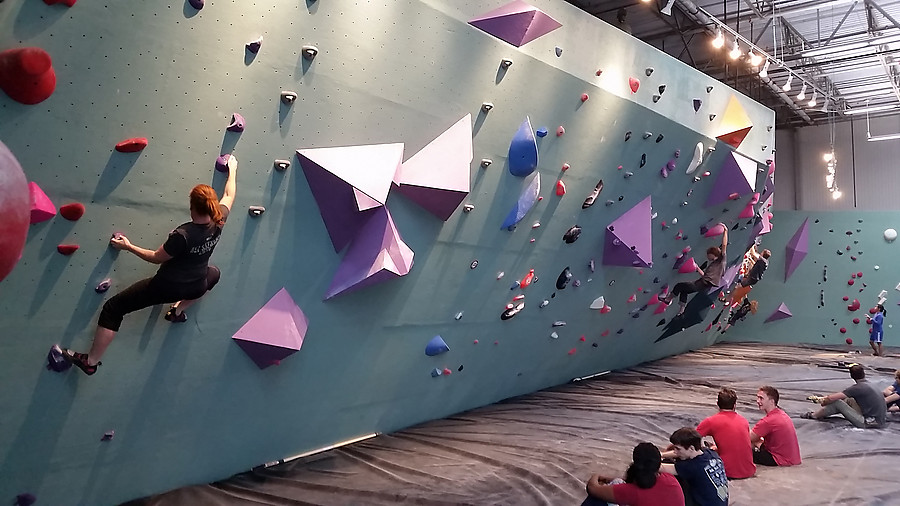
[726,211,900,348]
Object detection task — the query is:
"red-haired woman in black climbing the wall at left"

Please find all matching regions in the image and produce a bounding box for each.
[63,156,238,376]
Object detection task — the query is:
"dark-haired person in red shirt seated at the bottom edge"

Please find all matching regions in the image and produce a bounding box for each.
[581,443,684,506]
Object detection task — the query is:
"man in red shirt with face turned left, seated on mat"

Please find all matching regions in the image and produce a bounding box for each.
[750,386,800,466]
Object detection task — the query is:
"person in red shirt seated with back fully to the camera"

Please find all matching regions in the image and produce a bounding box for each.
[697,387,756,480]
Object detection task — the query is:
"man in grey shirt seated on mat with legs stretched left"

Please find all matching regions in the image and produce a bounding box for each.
[801,364,887,429]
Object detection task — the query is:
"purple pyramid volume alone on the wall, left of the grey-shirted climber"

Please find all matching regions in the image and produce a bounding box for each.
[603,196,653,267]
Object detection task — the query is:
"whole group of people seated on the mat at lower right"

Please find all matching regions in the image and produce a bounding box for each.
[582,365,900,506]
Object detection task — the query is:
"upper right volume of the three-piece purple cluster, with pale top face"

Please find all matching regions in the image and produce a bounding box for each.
[394,114,473,221]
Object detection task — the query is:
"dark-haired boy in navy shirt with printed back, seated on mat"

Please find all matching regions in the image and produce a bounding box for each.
[660,427,728,506]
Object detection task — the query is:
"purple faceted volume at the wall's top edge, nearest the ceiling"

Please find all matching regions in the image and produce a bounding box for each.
[469,0,562,47]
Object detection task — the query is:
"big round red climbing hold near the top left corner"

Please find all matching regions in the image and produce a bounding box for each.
[0,47,56,105]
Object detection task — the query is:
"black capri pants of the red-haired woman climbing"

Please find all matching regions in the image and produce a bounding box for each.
[97,265,222,332]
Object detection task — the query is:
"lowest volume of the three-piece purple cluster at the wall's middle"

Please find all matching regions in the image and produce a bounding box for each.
[325,206,414,300]
